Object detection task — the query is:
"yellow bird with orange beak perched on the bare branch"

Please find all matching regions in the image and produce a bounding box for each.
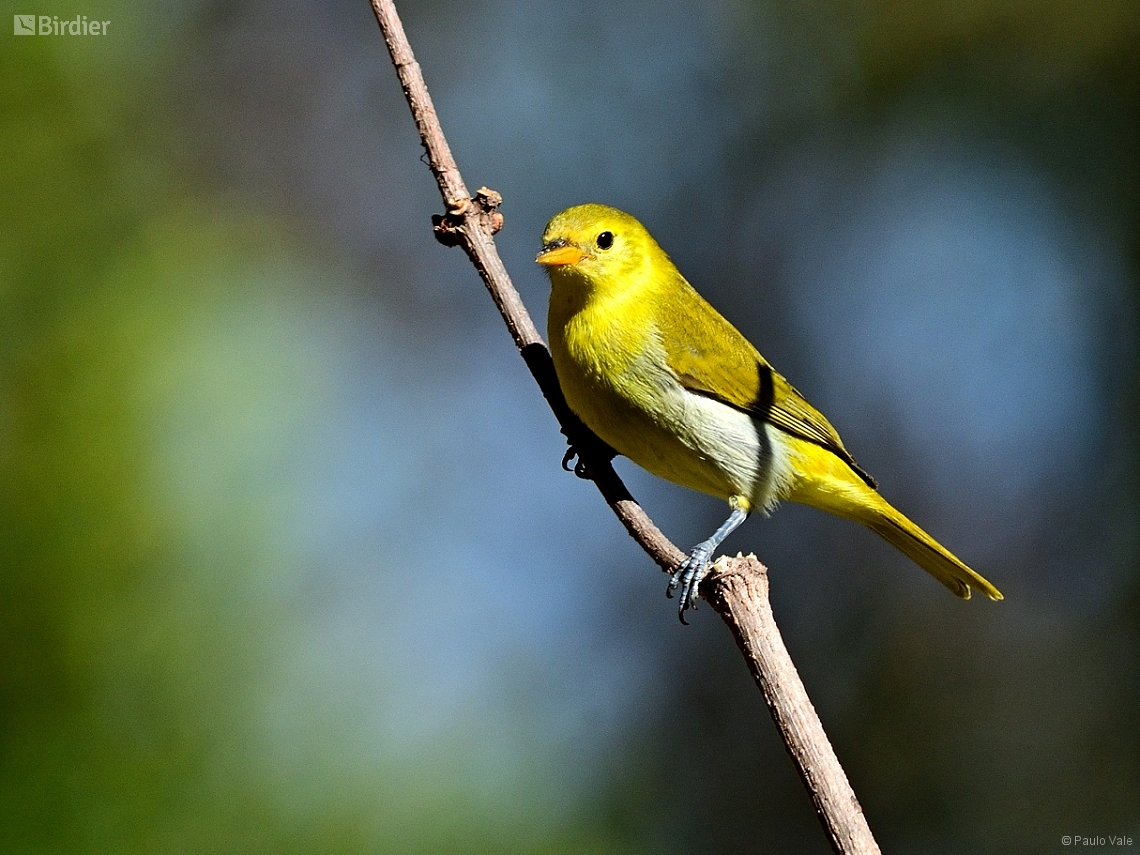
[536,204,1002,622]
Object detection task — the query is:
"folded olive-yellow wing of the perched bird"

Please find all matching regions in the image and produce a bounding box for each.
[659,279,878,489]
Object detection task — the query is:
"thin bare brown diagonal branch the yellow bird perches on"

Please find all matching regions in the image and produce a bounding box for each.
[371,0,879,855]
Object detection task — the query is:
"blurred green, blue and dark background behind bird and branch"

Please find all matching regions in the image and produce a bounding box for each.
[0,0,1140,855]
